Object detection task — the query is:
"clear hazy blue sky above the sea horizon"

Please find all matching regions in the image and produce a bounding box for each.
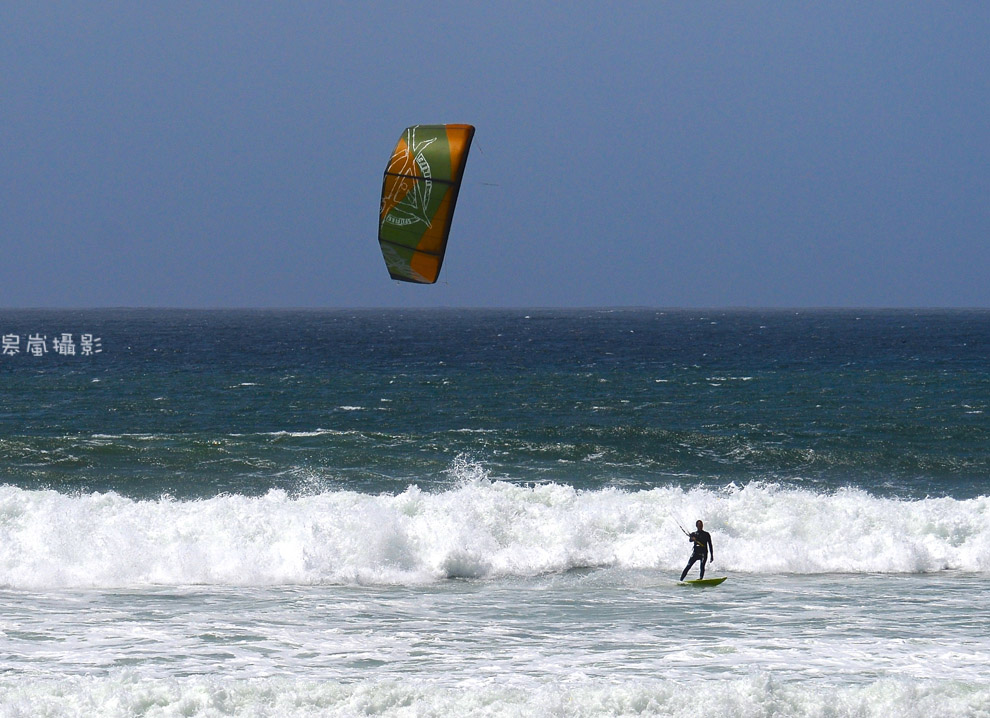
[0,0,990,308]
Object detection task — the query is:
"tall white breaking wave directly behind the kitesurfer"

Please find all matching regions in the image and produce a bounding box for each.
[0,480,990,589]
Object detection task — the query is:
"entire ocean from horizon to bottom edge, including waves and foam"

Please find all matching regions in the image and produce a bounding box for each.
[0,309,990,718]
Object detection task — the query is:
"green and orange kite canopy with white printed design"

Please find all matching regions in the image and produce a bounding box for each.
[378,125,474,284]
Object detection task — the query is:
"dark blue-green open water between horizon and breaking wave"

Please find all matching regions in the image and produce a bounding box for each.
[0,310,990,498]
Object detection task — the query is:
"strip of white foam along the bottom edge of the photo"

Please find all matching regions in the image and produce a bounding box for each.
[0,672,990,718]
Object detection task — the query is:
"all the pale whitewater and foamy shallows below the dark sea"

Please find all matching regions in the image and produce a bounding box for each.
[0,480,990,716]
